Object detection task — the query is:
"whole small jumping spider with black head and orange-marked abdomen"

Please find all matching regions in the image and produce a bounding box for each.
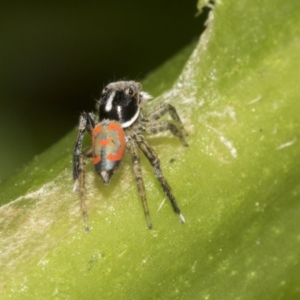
[73,81,188,231]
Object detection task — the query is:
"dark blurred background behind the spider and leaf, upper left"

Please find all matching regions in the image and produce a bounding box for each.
[0,0,207,180]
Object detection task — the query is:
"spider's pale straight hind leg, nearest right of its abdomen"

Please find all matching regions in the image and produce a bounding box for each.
[126,138,152,229]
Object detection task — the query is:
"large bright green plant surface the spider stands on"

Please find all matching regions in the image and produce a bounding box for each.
[0,0,300,299]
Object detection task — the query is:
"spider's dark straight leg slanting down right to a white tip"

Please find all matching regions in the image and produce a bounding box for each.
[136,135,185,223]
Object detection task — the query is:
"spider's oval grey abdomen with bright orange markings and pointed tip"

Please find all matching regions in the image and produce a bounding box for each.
[92,120,125,184]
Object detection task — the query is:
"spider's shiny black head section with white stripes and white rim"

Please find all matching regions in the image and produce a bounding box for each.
[98,81,152,128]
